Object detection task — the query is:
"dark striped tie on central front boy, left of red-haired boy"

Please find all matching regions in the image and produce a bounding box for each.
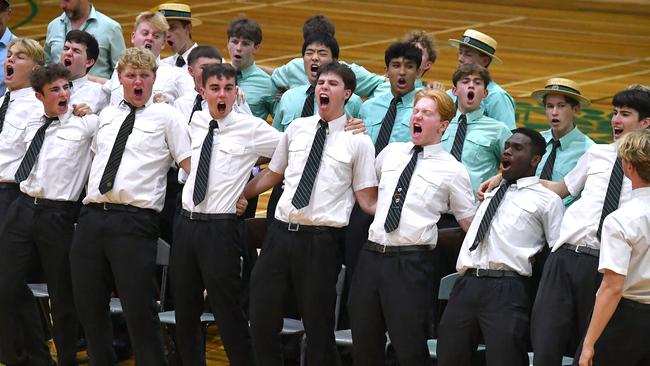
[291,119,329,209]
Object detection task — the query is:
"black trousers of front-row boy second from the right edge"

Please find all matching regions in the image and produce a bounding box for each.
[531,248,602,366]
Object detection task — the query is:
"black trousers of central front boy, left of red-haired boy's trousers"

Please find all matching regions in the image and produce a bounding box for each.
[250,221,345,366]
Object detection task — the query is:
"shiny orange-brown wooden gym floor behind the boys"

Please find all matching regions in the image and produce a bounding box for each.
[3,0,650,365]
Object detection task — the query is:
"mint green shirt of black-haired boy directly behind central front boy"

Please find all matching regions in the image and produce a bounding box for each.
[273,84,361,132]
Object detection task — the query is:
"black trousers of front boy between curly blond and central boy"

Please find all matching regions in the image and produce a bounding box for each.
[170,217,253,366]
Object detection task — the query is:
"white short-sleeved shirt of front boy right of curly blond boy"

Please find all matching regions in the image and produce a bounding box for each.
[183,110,281,213]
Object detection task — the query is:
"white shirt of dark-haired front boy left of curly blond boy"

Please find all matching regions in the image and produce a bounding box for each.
[20,110,99,202]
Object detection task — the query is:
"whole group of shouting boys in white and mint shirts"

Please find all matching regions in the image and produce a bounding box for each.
[0,4,650,366]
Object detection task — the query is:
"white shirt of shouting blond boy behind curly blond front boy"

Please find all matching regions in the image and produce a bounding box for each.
[103,60,195,105]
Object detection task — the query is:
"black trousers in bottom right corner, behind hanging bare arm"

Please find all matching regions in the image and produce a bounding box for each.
[573,298,650,366]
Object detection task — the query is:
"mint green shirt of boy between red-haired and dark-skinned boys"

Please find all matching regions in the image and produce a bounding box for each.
[442,108,512,194]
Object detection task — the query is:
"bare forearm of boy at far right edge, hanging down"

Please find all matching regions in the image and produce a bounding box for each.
[580,269,625,366]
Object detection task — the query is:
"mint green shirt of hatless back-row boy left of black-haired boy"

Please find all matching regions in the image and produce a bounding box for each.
[237,62,276,120]
